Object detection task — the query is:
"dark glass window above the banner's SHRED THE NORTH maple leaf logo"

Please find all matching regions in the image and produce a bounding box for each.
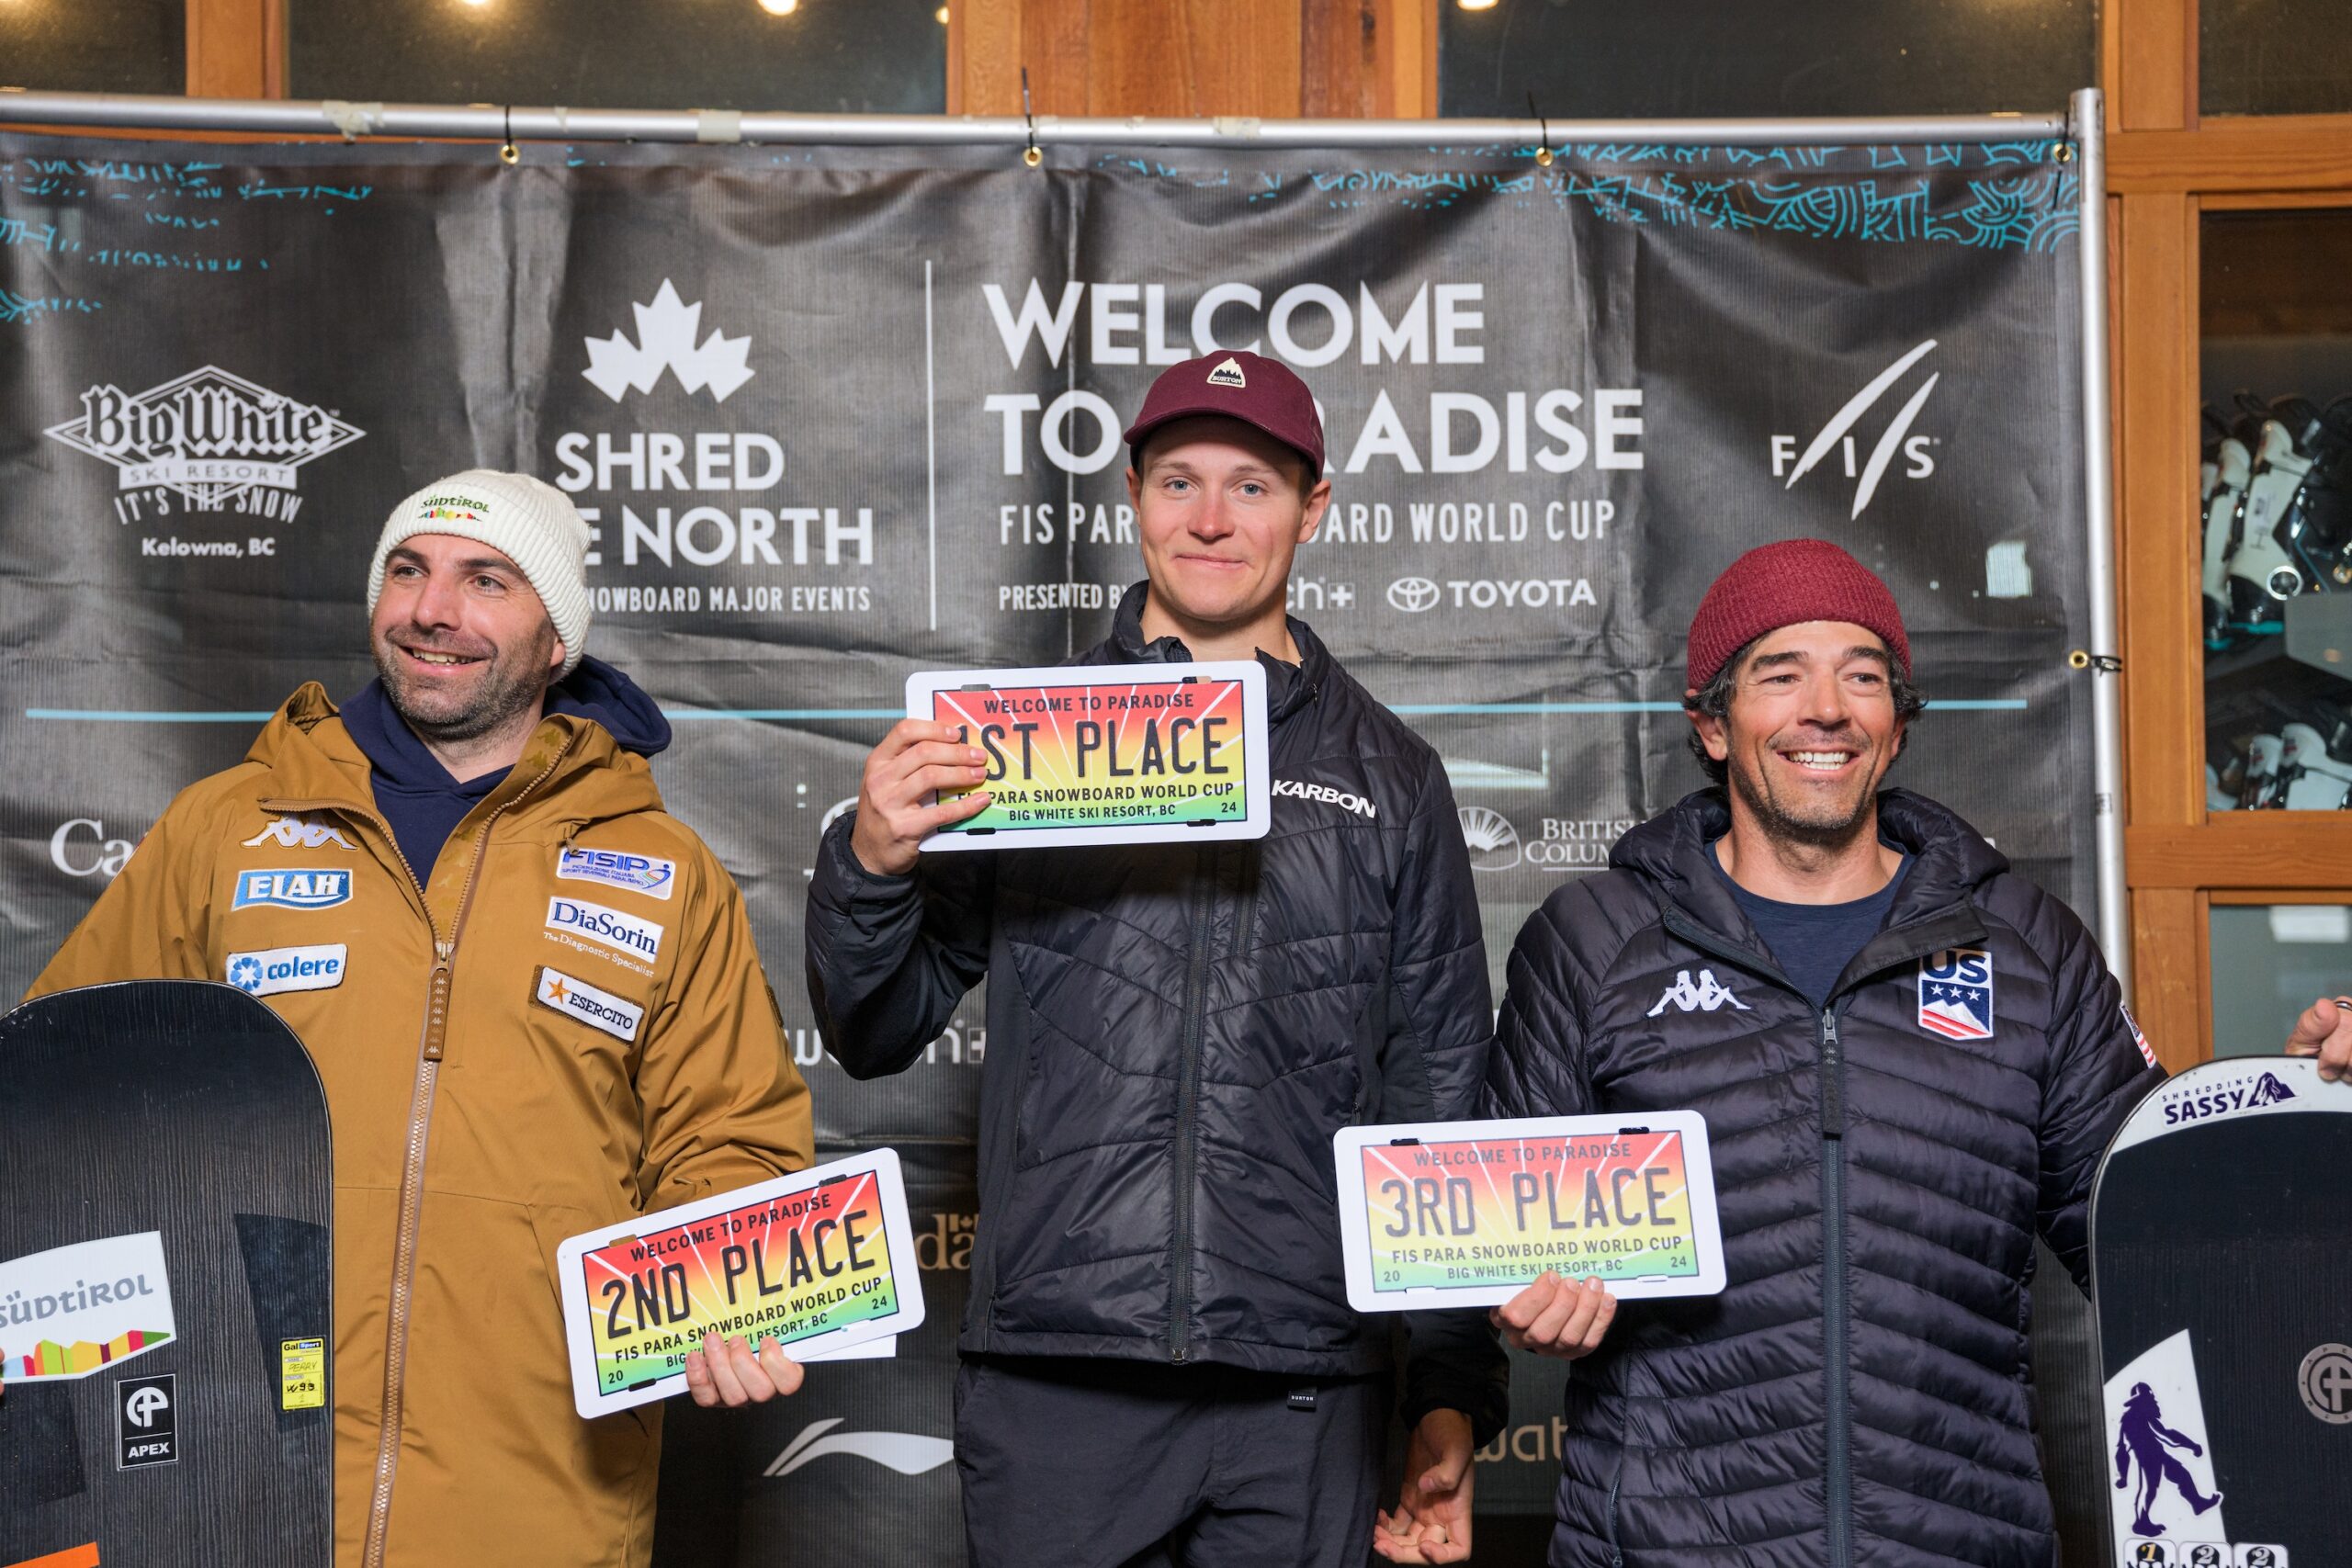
[294,0,948,115]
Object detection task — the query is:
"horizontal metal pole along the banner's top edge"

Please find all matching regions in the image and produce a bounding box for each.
[0,92,2067,155]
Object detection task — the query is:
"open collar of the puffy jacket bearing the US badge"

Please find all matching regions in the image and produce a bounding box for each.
[1609,787,2008,989]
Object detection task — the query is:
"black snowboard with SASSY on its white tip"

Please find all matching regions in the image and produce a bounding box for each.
[2091,1058,2352,1568]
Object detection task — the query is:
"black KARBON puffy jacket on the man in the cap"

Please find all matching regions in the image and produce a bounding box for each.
[807,585,1503,1441]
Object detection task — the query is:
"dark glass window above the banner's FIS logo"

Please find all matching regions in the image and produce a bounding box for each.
[1437,0,2098,120]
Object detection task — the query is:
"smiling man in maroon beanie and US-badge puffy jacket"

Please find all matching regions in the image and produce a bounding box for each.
[1482,538,2164,1568]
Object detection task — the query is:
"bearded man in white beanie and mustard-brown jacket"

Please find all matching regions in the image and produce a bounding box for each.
[33,470,811,1568]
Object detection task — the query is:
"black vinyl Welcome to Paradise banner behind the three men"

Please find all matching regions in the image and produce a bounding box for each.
[0,136,2093,1563]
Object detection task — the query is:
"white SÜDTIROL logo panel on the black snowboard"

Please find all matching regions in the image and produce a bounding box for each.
[0,1229,179,1382]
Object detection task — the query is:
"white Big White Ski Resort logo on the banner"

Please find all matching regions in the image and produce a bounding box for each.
[45,365,365,558]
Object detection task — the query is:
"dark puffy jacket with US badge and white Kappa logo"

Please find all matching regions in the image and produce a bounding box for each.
[1484,790,2162,1568]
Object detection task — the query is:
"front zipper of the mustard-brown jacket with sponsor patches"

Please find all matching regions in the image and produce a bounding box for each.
[270,745,571,1568]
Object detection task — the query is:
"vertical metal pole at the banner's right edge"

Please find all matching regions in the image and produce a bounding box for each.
[2070,87,2131,999]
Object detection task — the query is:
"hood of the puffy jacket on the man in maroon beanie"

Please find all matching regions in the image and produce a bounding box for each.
[1609,787,2008,936]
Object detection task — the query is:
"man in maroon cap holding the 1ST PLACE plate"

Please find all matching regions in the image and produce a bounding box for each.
[807,350,1505,1568]
